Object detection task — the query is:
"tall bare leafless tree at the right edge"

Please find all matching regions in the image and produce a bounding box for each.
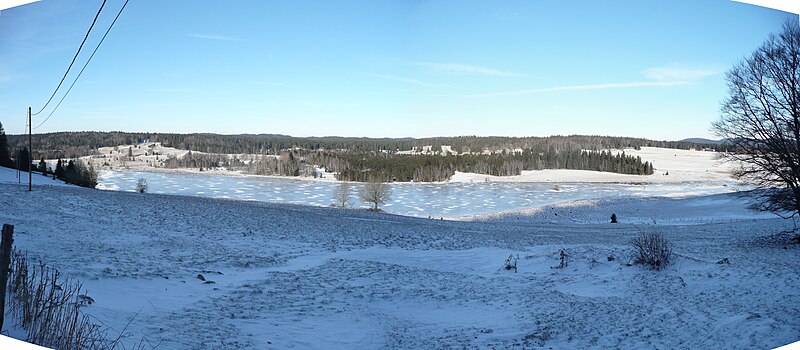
[712,21,800,217]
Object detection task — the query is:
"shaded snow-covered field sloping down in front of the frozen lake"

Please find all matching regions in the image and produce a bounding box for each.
[0,166,800,349]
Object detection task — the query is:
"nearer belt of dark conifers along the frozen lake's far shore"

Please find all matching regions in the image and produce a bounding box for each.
[184,150,653,182]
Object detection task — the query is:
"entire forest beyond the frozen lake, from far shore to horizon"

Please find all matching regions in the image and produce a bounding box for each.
[8,132,724,181]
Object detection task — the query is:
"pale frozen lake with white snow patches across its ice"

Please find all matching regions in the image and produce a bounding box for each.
[97,171,736,218]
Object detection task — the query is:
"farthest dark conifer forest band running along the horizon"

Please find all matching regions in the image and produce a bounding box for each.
[8,131,727,159]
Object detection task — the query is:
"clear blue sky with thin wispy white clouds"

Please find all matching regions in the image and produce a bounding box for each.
[0,0,797,140]
